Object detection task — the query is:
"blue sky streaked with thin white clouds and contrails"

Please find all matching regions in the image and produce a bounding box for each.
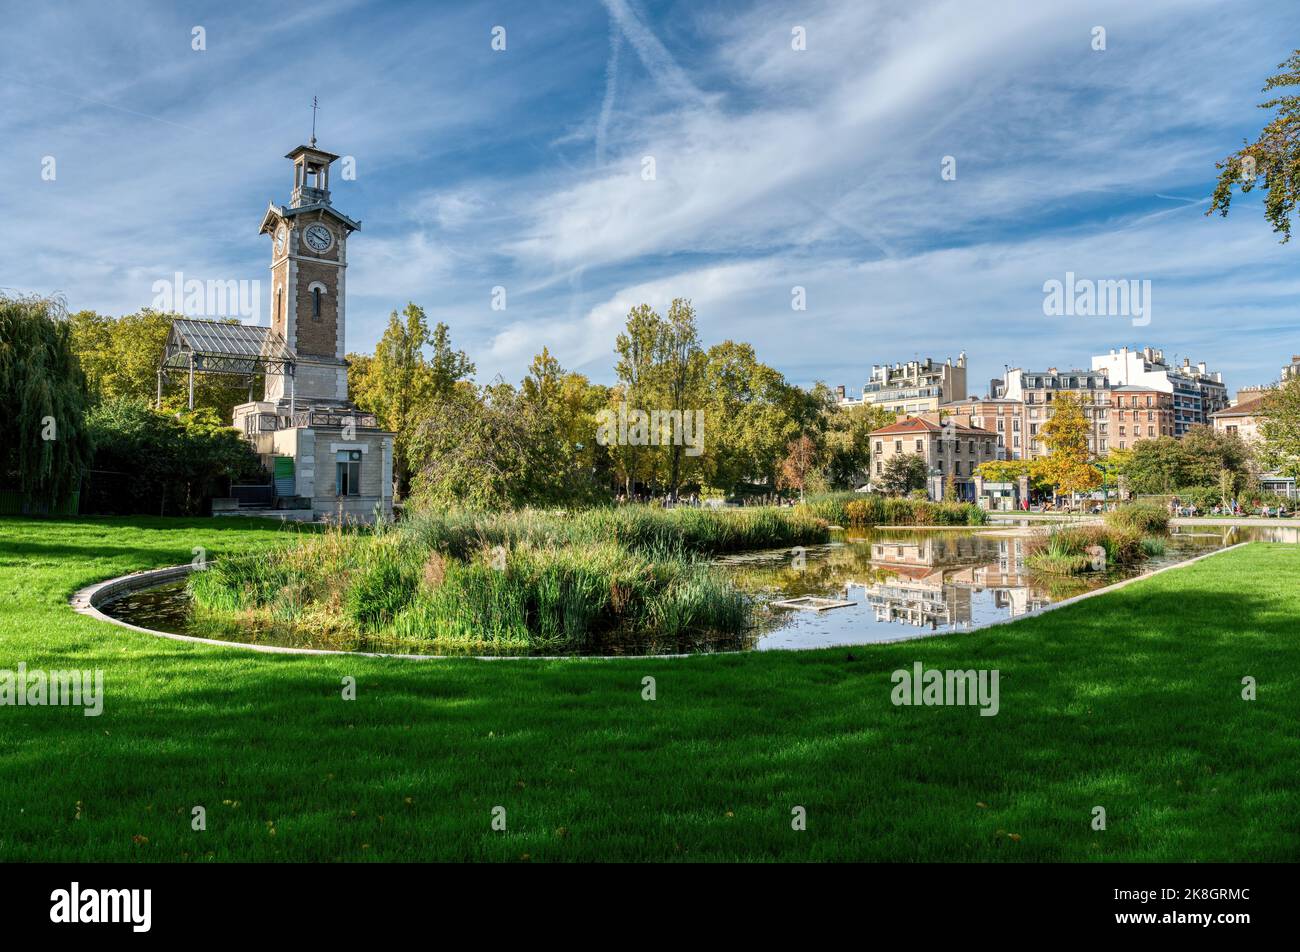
[0,0,1300,391]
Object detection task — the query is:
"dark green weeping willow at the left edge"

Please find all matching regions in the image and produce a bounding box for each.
[0,297,91,506]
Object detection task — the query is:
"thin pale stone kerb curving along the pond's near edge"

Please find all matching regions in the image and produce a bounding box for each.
[69,541,1251,661]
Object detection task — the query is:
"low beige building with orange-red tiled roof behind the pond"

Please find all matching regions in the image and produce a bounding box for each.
[871,411,997,502]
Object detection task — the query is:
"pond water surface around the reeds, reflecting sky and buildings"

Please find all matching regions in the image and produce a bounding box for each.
[101,518,1300,654]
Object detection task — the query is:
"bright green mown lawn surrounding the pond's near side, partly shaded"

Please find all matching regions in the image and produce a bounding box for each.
[0,519,1300,861]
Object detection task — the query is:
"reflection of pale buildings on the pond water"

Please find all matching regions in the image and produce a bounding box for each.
[863,538,1050,631]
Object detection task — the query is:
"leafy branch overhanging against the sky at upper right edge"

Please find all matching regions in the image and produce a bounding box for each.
[1205,49,1300,245]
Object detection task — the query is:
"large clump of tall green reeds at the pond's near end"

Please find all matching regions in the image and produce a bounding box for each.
[190,506,828,653]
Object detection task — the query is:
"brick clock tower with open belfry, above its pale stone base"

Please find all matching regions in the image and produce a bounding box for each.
[260,142,361,406]
